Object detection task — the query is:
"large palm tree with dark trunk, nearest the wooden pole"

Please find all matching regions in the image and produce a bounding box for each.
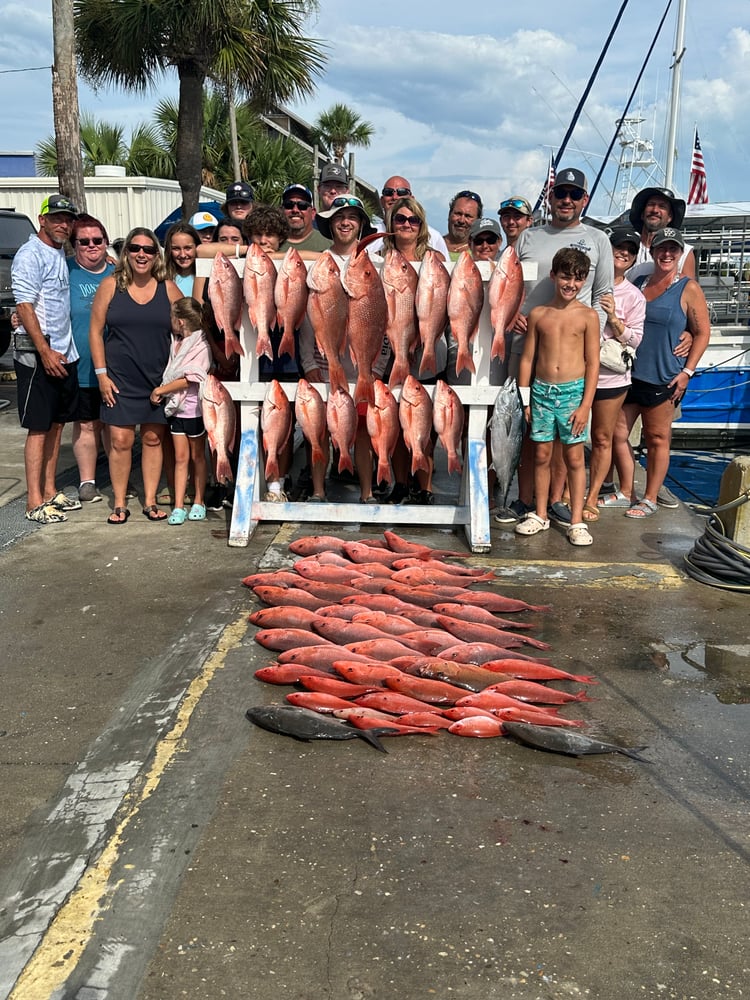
[75,0,325,216]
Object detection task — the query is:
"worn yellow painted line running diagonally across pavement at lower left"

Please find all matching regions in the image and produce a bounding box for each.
[8,614,248,1000]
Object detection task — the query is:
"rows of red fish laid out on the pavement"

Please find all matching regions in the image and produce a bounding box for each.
[243,531,648,755]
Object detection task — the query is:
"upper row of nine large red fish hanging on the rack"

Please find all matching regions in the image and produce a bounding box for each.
[208,245,524,394]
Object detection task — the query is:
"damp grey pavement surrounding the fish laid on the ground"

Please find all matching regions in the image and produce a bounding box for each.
[0,358,750,1000]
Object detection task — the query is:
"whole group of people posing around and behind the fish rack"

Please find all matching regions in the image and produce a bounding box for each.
[8,163,709,545]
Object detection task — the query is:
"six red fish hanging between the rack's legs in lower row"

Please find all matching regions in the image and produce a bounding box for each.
[261,375,464,483]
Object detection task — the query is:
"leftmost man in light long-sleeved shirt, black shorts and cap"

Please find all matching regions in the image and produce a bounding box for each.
[11,194,81,524]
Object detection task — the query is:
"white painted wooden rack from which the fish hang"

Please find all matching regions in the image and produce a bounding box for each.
[197,259,535,553]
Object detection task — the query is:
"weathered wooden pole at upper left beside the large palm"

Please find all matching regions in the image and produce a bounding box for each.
[52,0,86,212]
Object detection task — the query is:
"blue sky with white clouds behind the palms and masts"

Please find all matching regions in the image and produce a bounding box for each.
[0,0,750,232]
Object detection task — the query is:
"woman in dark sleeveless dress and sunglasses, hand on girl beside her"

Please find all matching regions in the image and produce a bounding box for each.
[89,227,182,524]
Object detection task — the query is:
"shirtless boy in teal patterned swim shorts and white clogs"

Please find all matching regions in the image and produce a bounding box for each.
[515,247,599,545]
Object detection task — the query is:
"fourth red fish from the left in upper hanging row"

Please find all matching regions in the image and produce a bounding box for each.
[307,252,349,392]
